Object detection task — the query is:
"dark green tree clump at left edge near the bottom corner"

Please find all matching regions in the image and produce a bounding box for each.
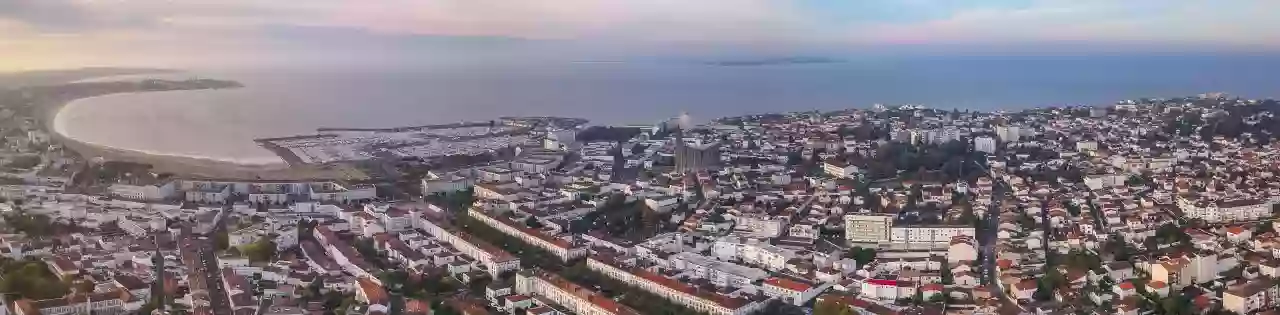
[0,259,69,300]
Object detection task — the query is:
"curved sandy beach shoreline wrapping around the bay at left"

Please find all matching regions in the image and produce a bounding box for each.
[43,91,367,181]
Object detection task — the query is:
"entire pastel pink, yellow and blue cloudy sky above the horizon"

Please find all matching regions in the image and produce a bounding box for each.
[0,0,1280,70]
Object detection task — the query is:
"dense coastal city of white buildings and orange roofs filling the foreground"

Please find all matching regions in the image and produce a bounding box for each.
[0,93,1280,315]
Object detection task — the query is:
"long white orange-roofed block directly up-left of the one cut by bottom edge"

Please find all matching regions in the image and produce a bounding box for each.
[413,213,520,278]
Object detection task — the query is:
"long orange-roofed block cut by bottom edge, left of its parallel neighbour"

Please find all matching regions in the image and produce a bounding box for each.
[516,269,640,315]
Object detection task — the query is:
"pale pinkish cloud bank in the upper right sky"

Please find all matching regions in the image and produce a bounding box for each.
[867,0,1280,45]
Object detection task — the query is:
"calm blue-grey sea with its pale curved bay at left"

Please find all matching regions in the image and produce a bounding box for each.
[55,55,1280,164]
